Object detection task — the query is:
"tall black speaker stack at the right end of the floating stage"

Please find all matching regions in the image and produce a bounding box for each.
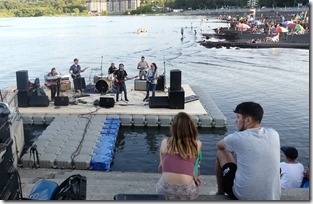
[168,69,185,109]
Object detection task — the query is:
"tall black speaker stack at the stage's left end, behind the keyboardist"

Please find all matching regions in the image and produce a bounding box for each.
[16,70,30,107]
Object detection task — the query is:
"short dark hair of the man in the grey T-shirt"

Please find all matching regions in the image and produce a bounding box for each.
[234,102,264,123]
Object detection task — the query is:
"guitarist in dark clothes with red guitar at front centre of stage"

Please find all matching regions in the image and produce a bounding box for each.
[113,63,128,102]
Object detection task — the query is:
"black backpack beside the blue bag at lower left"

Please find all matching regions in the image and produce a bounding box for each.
[54,174,87,200]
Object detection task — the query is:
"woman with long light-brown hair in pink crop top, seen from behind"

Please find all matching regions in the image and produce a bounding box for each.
[156,112,202,200]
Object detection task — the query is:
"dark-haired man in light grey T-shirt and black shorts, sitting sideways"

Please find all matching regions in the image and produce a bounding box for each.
[215,102,281,200]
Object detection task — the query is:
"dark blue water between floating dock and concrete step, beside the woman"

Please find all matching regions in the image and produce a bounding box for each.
[112,127,227,174]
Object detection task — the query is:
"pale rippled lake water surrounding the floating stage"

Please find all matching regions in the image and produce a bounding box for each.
[0,16,310,174]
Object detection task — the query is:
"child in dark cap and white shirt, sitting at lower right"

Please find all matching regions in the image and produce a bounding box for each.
[280,146,304,188]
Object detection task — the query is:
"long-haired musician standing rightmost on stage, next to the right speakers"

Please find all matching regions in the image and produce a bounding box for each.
[143,62,159,101]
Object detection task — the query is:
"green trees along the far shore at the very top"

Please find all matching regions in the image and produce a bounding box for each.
[0,0,309,17]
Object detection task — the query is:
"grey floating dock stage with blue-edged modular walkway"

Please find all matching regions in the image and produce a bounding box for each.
[4,83,227,171]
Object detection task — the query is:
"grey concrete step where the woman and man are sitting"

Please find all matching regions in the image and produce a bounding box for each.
[19,168,310,200]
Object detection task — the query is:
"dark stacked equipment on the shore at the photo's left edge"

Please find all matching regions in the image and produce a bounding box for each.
[0,104,19,200]
